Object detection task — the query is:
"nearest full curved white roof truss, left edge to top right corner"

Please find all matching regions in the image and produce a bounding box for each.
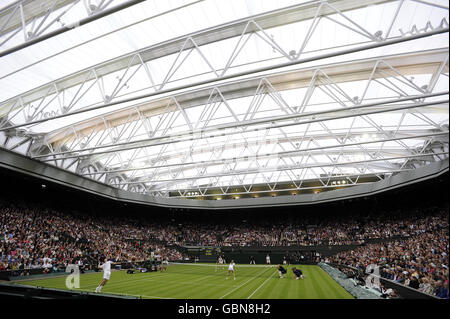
[0,0,448,129]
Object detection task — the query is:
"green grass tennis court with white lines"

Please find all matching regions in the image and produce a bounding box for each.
[17,264,353,299]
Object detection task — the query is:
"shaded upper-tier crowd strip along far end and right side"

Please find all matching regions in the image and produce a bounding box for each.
[163,207,448,247]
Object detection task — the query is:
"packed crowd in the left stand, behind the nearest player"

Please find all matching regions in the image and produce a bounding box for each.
[0,204,185,270]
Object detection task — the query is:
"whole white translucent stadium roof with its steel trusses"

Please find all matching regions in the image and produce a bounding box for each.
[0,0,449,208]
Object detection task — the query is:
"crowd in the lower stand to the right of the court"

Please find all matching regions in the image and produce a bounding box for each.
[330,225,449,299]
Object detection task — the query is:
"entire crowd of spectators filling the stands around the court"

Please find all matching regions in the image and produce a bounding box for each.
[0,196,449,298]
